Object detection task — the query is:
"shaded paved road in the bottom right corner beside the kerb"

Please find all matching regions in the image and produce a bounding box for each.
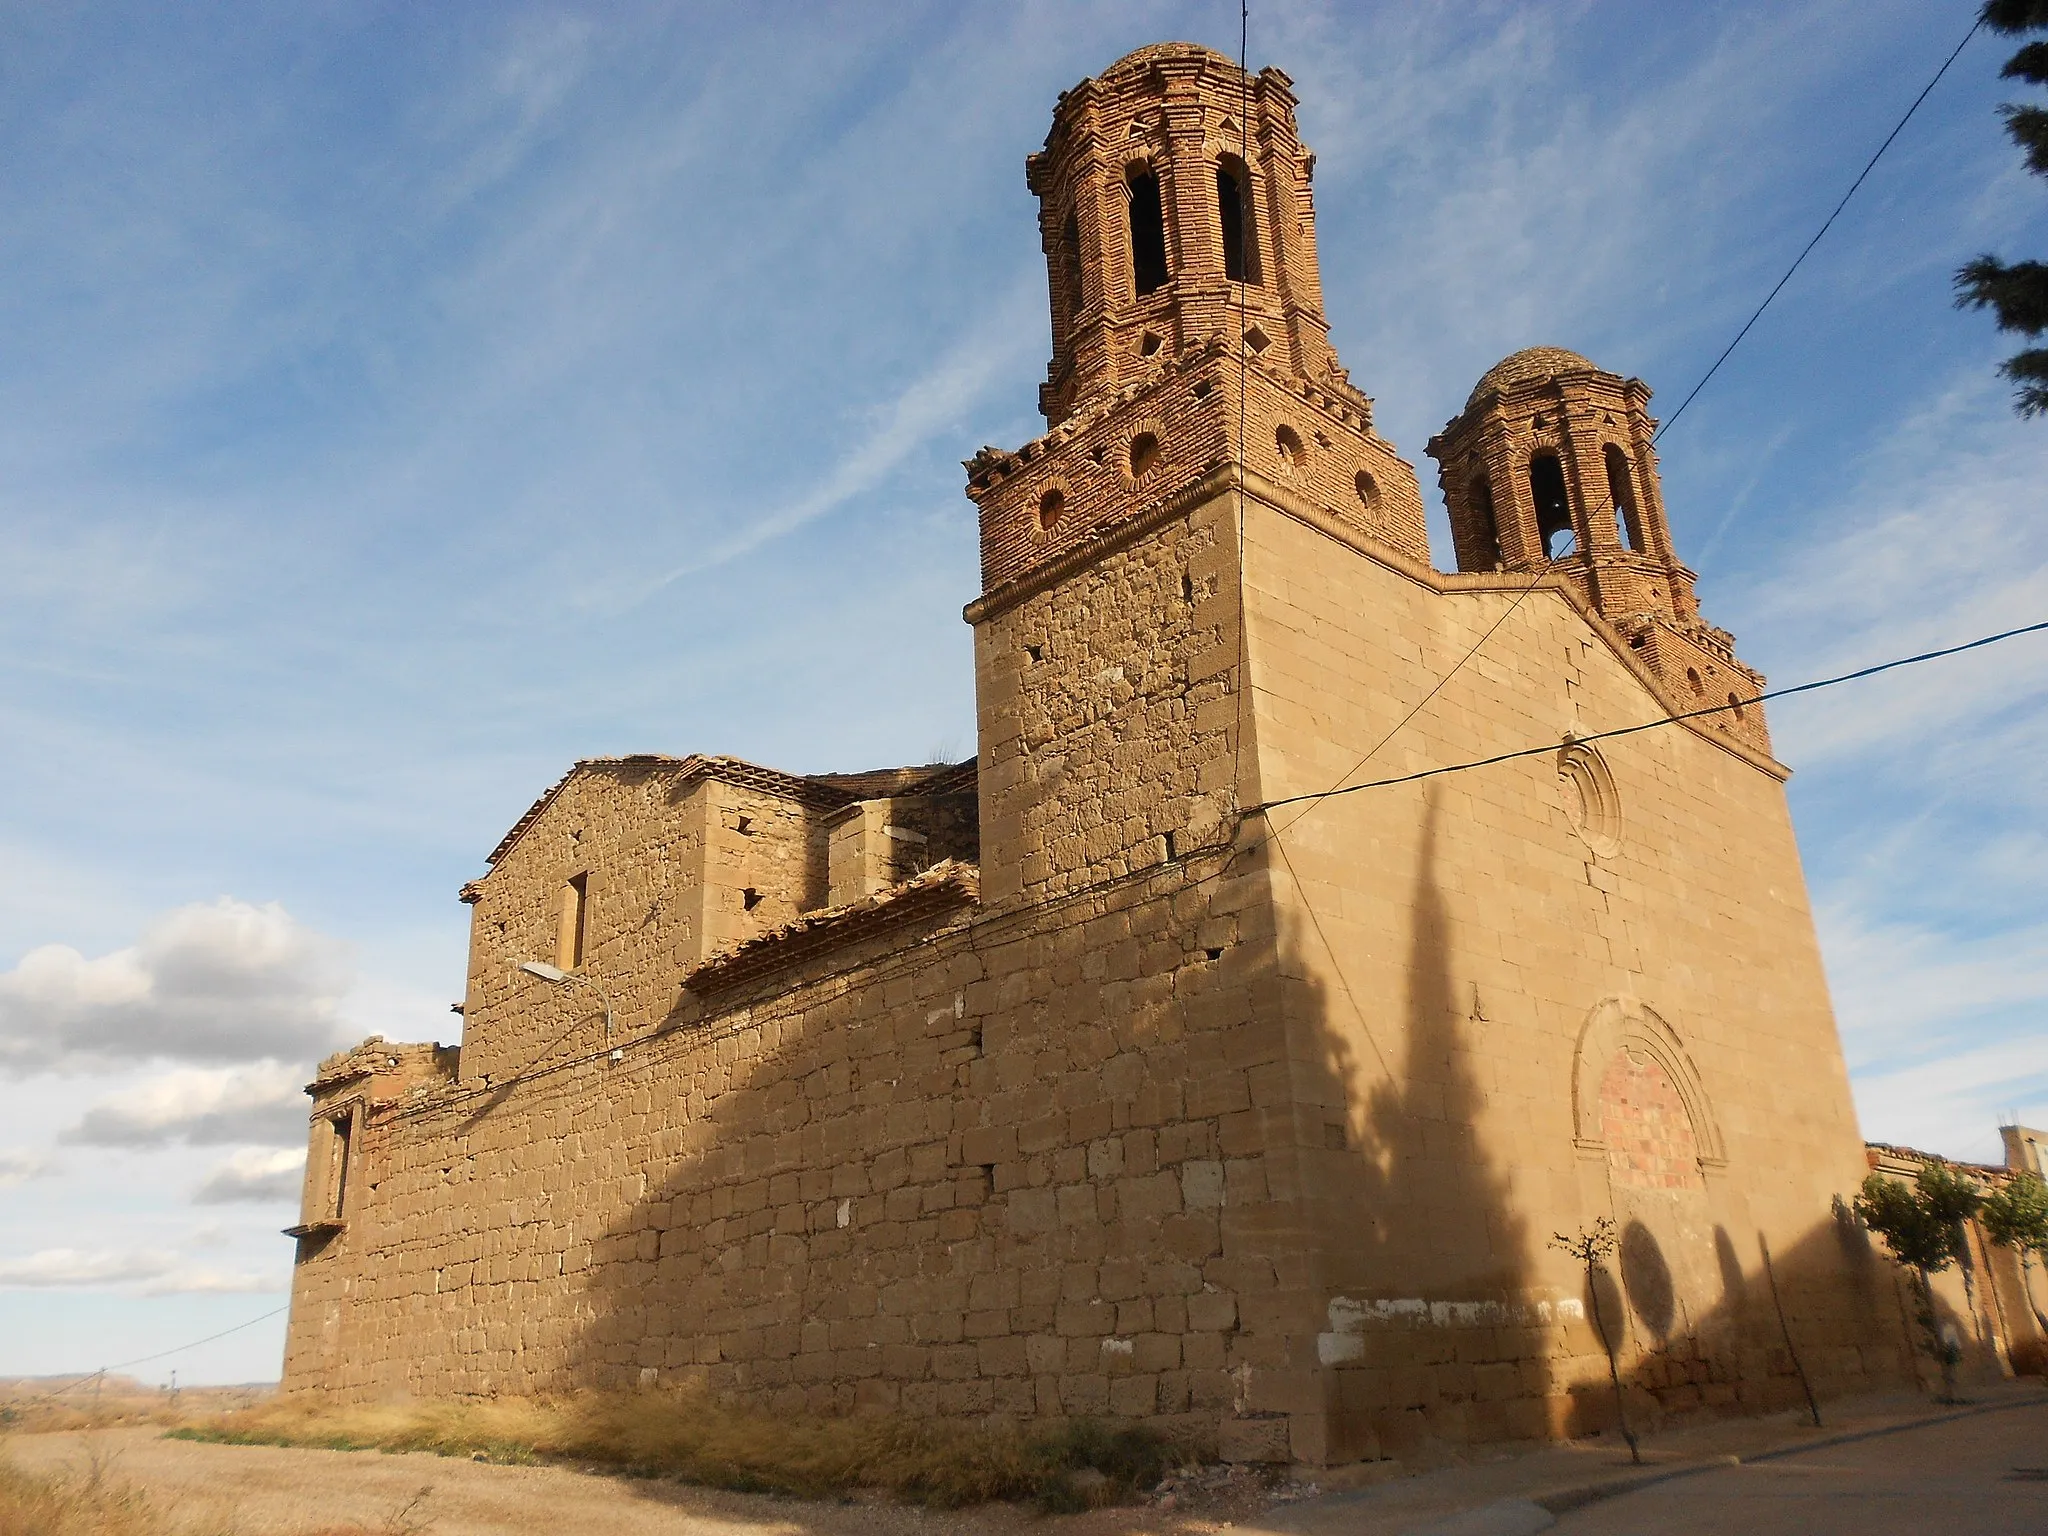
[1554,1401,2048,1536]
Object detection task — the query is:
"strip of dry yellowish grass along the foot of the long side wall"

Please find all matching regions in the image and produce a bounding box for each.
[172,1391,1174,1509]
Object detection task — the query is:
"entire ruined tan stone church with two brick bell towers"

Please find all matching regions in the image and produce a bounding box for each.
[285,43,1909,1464]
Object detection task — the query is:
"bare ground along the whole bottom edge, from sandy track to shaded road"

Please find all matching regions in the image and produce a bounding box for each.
[0,1380,2048,1536]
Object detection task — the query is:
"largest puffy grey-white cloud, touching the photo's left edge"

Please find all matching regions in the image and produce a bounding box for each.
[0,897,348,1071]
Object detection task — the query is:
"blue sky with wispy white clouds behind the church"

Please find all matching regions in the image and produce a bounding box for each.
[0,0,2048,1380]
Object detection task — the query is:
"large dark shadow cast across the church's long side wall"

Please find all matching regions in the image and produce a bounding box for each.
[559,847,1310,1446]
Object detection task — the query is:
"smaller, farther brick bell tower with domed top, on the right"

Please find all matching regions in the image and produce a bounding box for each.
[1427,346,1769,754]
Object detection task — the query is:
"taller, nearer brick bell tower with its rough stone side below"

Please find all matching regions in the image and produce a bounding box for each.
[965,43,1430,901]
